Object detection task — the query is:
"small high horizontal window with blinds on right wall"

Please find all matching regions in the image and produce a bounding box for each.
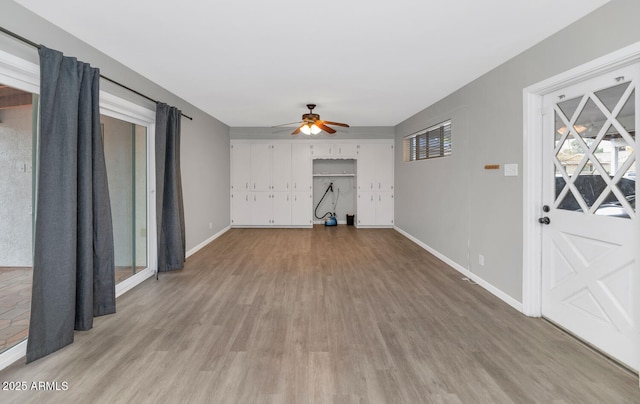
[404,120,451,161]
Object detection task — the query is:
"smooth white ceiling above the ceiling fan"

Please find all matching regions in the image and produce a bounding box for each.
[15,0,608,127]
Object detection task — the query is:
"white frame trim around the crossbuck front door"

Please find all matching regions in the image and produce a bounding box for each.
[522,42,640,317]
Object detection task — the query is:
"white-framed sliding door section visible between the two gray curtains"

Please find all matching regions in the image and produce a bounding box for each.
[100,91,157,296]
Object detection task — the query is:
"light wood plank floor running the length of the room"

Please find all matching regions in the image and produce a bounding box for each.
[0,226,640,403]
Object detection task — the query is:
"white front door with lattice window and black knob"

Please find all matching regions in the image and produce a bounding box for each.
[540,64,640,369]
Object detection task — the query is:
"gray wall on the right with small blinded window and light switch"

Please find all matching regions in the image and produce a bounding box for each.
[395,0,640,301]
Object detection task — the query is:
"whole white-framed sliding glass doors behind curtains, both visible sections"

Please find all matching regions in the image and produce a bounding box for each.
[0,50,156,362]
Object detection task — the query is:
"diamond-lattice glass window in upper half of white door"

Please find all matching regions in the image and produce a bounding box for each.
[554,77,636,218]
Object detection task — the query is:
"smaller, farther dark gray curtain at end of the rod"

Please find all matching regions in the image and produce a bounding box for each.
[156,103,185,272]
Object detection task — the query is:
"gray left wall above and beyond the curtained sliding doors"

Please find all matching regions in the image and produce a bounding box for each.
[0,0,230,256]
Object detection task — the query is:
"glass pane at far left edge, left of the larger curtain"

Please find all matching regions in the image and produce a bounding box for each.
[0,83,38,352]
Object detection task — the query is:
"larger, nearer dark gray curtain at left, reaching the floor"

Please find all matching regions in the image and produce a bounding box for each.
[27,47,115,362]
